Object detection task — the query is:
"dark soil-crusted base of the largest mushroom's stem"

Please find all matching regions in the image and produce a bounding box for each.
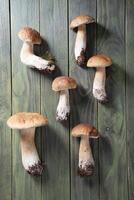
[27,161,44,176]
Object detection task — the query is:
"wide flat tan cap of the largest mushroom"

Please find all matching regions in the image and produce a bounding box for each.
[7,112,48,129]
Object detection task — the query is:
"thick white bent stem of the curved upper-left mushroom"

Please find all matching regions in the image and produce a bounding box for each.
[20,42,55,71]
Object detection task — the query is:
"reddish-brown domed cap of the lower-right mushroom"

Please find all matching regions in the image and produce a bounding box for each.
[71,124,99,138]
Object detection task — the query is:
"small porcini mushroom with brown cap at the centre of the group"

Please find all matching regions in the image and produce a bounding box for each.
[52,76,77,121]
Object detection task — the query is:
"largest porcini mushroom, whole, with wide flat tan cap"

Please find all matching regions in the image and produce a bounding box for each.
[7,112,48,175]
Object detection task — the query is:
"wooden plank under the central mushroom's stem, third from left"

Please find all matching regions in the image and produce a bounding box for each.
[40,0,70,200]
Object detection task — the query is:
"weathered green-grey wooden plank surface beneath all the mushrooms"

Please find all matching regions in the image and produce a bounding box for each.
[0,0,134,200]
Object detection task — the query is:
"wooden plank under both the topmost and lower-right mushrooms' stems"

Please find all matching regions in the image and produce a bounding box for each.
[69,0,99,200]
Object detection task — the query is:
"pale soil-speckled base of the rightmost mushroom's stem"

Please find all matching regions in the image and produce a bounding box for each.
[93,88,108,104]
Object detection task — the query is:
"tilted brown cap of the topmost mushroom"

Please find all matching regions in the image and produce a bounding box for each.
[70,15,95,28]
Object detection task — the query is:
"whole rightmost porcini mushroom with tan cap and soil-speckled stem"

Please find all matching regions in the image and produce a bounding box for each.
[87,54,112,103]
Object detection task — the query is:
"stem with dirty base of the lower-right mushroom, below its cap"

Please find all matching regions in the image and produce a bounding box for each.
[78,136,94,176]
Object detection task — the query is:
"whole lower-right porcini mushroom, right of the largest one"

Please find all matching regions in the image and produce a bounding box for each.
[71,124,99,176]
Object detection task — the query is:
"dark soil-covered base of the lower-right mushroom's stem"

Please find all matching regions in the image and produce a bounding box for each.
[77,161,94,176]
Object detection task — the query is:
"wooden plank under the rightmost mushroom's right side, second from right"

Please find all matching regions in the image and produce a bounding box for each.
[97,0,128,200]
